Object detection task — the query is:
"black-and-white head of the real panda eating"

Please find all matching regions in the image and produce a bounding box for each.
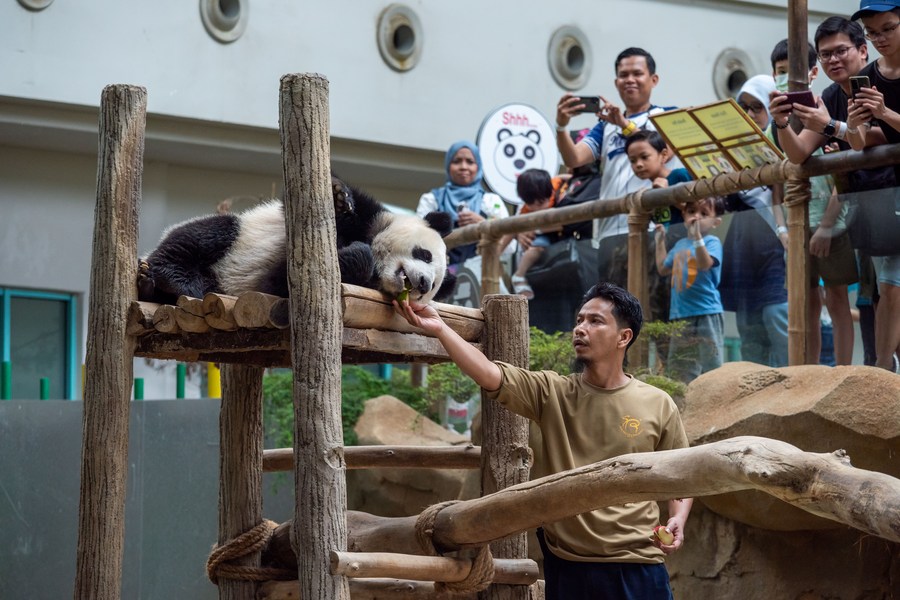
[371,211,452,304]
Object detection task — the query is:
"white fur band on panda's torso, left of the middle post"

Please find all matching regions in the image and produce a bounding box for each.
[213,200,287,295]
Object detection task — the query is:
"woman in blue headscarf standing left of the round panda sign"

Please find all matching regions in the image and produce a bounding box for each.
[416,140,509,269]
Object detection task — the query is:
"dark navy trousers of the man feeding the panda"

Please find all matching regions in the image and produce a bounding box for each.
[537,529,672,600]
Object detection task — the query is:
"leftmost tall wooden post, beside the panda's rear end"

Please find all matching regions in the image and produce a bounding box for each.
[74,85,147,600]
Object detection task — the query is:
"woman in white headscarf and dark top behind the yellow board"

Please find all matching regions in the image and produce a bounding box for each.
[719,75,788,367]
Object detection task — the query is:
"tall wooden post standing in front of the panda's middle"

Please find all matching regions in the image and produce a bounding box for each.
[280,74,350,600]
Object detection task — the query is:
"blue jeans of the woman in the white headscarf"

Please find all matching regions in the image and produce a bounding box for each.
[736,302,788,367]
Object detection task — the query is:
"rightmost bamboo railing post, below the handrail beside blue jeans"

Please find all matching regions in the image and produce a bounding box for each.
[776,179,819,366]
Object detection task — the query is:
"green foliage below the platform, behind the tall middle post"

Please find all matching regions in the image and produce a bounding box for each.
[263,365,428,448]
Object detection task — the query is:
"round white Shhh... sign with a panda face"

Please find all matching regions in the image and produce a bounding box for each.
[475,104,560,205]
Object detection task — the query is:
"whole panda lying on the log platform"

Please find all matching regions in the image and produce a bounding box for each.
[138,177,456,304]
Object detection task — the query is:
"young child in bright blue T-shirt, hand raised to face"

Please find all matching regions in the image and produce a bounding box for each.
[656,198,725,383]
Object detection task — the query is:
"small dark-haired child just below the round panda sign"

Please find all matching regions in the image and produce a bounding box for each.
[500,169,556,300]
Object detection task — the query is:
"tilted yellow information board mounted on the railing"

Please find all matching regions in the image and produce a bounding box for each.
[650,98,782,179]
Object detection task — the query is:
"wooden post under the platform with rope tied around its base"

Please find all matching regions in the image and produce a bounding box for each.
[219,365,263,600]
